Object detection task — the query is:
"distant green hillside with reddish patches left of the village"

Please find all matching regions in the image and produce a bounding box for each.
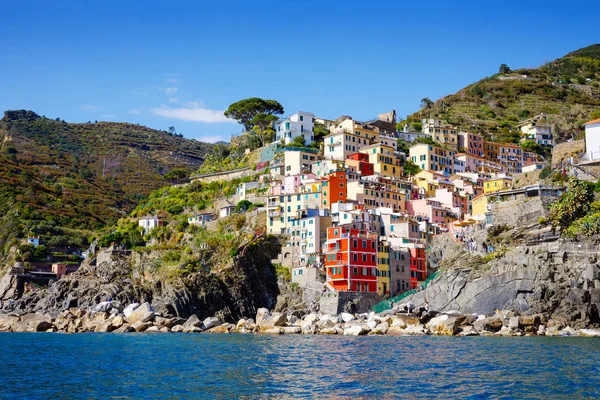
[0,110,213,256]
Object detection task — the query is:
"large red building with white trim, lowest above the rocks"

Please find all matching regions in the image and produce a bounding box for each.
[324,226,377,292]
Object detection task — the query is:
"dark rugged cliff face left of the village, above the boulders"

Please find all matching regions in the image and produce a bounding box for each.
[3,239,279,321]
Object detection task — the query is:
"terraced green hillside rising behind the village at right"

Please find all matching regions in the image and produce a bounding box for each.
[407,44,600,142]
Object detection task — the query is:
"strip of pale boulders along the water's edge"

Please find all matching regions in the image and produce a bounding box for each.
[0,302,600,337]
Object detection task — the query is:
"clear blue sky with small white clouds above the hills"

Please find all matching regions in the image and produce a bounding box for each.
[0,0,600,141]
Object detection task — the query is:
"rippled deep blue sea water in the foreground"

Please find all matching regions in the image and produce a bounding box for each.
[0,333,600,399]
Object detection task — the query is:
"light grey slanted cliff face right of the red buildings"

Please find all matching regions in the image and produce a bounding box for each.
[403,200,600,329]
